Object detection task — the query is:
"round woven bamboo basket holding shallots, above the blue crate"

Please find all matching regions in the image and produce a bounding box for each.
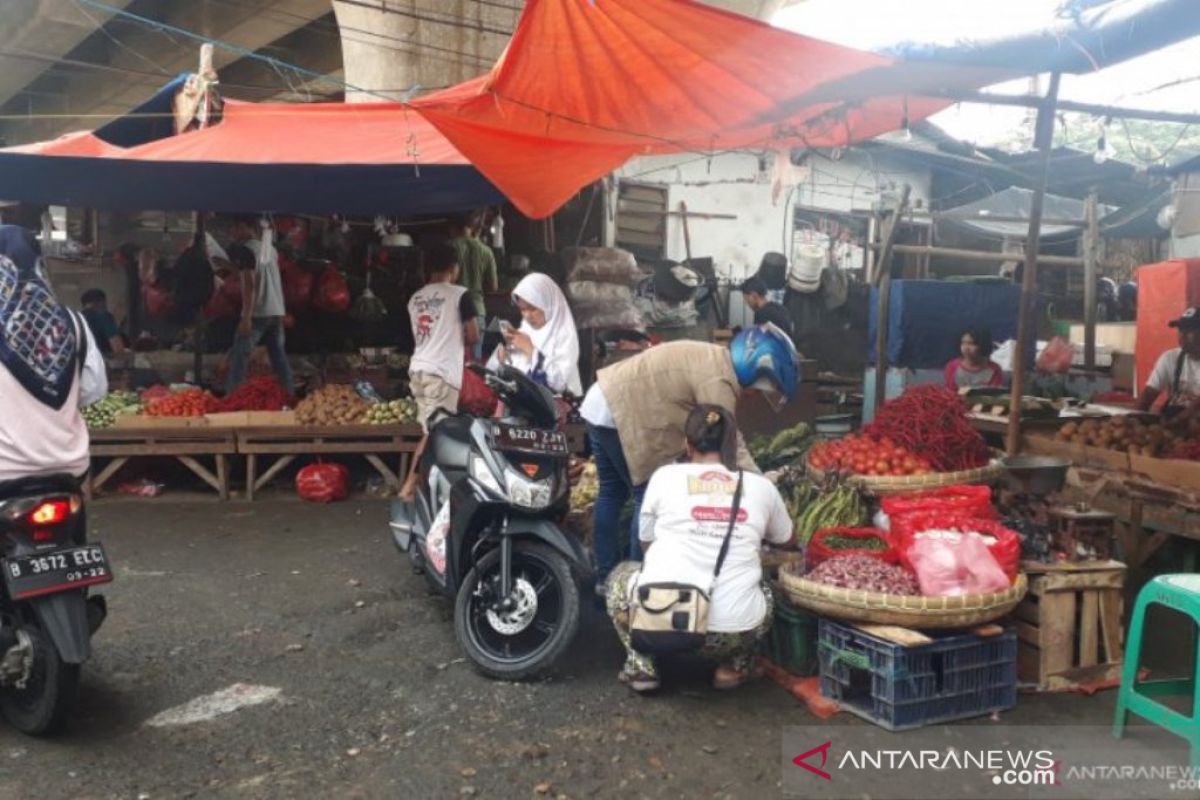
[779,569,1028,630]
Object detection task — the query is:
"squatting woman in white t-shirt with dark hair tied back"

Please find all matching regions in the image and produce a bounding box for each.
[607,405,792,692]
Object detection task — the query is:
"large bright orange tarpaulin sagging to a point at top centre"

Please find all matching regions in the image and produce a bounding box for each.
[413,0,1007,217]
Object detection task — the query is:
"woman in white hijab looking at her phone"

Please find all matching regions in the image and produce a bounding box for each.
[497,272,583,397]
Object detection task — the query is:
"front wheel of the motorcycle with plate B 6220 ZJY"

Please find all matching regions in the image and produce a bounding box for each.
[455,541,580,680]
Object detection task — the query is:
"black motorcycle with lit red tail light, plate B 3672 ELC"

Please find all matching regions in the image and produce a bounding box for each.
[0,476,113,735]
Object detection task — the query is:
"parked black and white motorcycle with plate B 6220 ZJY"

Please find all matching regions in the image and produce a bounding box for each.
[391,366,590,680]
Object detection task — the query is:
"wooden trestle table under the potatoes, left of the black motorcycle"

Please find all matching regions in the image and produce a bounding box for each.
[236,423,421,500]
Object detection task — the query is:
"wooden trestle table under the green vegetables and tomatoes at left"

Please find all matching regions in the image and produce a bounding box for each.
[85,426,238,500]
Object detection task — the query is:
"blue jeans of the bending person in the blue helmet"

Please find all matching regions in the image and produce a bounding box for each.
[588,423,646,583]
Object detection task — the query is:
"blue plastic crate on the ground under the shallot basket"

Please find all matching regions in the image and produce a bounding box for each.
[817,619,1016,730]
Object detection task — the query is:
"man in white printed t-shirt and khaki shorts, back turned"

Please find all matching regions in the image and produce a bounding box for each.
[400,245,480,501]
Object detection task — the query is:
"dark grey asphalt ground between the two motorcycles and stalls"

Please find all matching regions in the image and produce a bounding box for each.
[0,497,1112,800]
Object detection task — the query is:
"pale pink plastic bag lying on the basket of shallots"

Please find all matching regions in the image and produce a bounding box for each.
[908,531,1009,597]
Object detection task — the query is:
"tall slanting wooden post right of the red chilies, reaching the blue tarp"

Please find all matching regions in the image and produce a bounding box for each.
[1006,72,1062,456]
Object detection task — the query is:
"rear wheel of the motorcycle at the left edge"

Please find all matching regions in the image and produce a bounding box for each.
[0,627,79,736]
